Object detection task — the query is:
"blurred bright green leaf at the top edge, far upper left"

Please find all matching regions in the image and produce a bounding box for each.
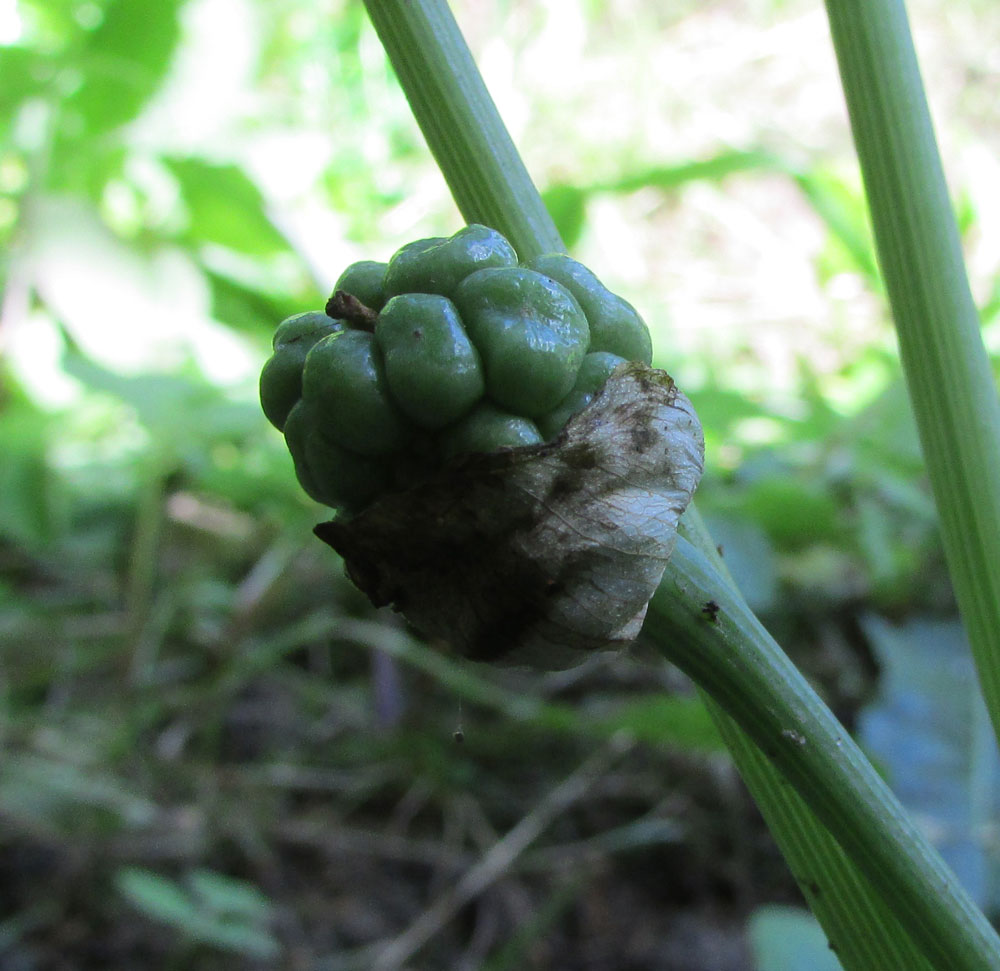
[63,0,184,136]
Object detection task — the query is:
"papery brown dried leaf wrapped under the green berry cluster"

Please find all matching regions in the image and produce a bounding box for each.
[316,363,704,668]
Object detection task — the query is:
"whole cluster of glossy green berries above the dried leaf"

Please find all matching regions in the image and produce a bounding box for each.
[260,225,652,510]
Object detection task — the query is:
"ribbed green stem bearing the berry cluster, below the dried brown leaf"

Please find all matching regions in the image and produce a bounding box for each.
[644,537,1000,971]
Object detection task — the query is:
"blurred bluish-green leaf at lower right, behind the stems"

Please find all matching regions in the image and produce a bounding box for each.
[858,616,1000,909]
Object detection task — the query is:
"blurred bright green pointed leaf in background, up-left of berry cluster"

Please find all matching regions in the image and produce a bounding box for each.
[165,158,288,256]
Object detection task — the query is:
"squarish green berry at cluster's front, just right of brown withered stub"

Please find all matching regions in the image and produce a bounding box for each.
[375,293,485,428]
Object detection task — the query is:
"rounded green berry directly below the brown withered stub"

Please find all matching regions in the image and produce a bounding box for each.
[302,330,407,455]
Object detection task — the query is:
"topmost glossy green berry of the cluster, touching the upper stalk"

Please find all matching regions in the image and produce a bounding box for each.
[385,223,517,298]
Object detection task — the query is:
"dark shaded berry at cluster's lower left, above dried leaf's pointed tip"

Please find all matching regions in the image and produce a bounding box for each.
[285,401,389,508]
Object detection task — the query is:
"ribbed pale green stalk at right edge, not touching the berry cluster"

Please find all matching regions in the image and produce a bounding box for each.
[827,0,1000,733]
